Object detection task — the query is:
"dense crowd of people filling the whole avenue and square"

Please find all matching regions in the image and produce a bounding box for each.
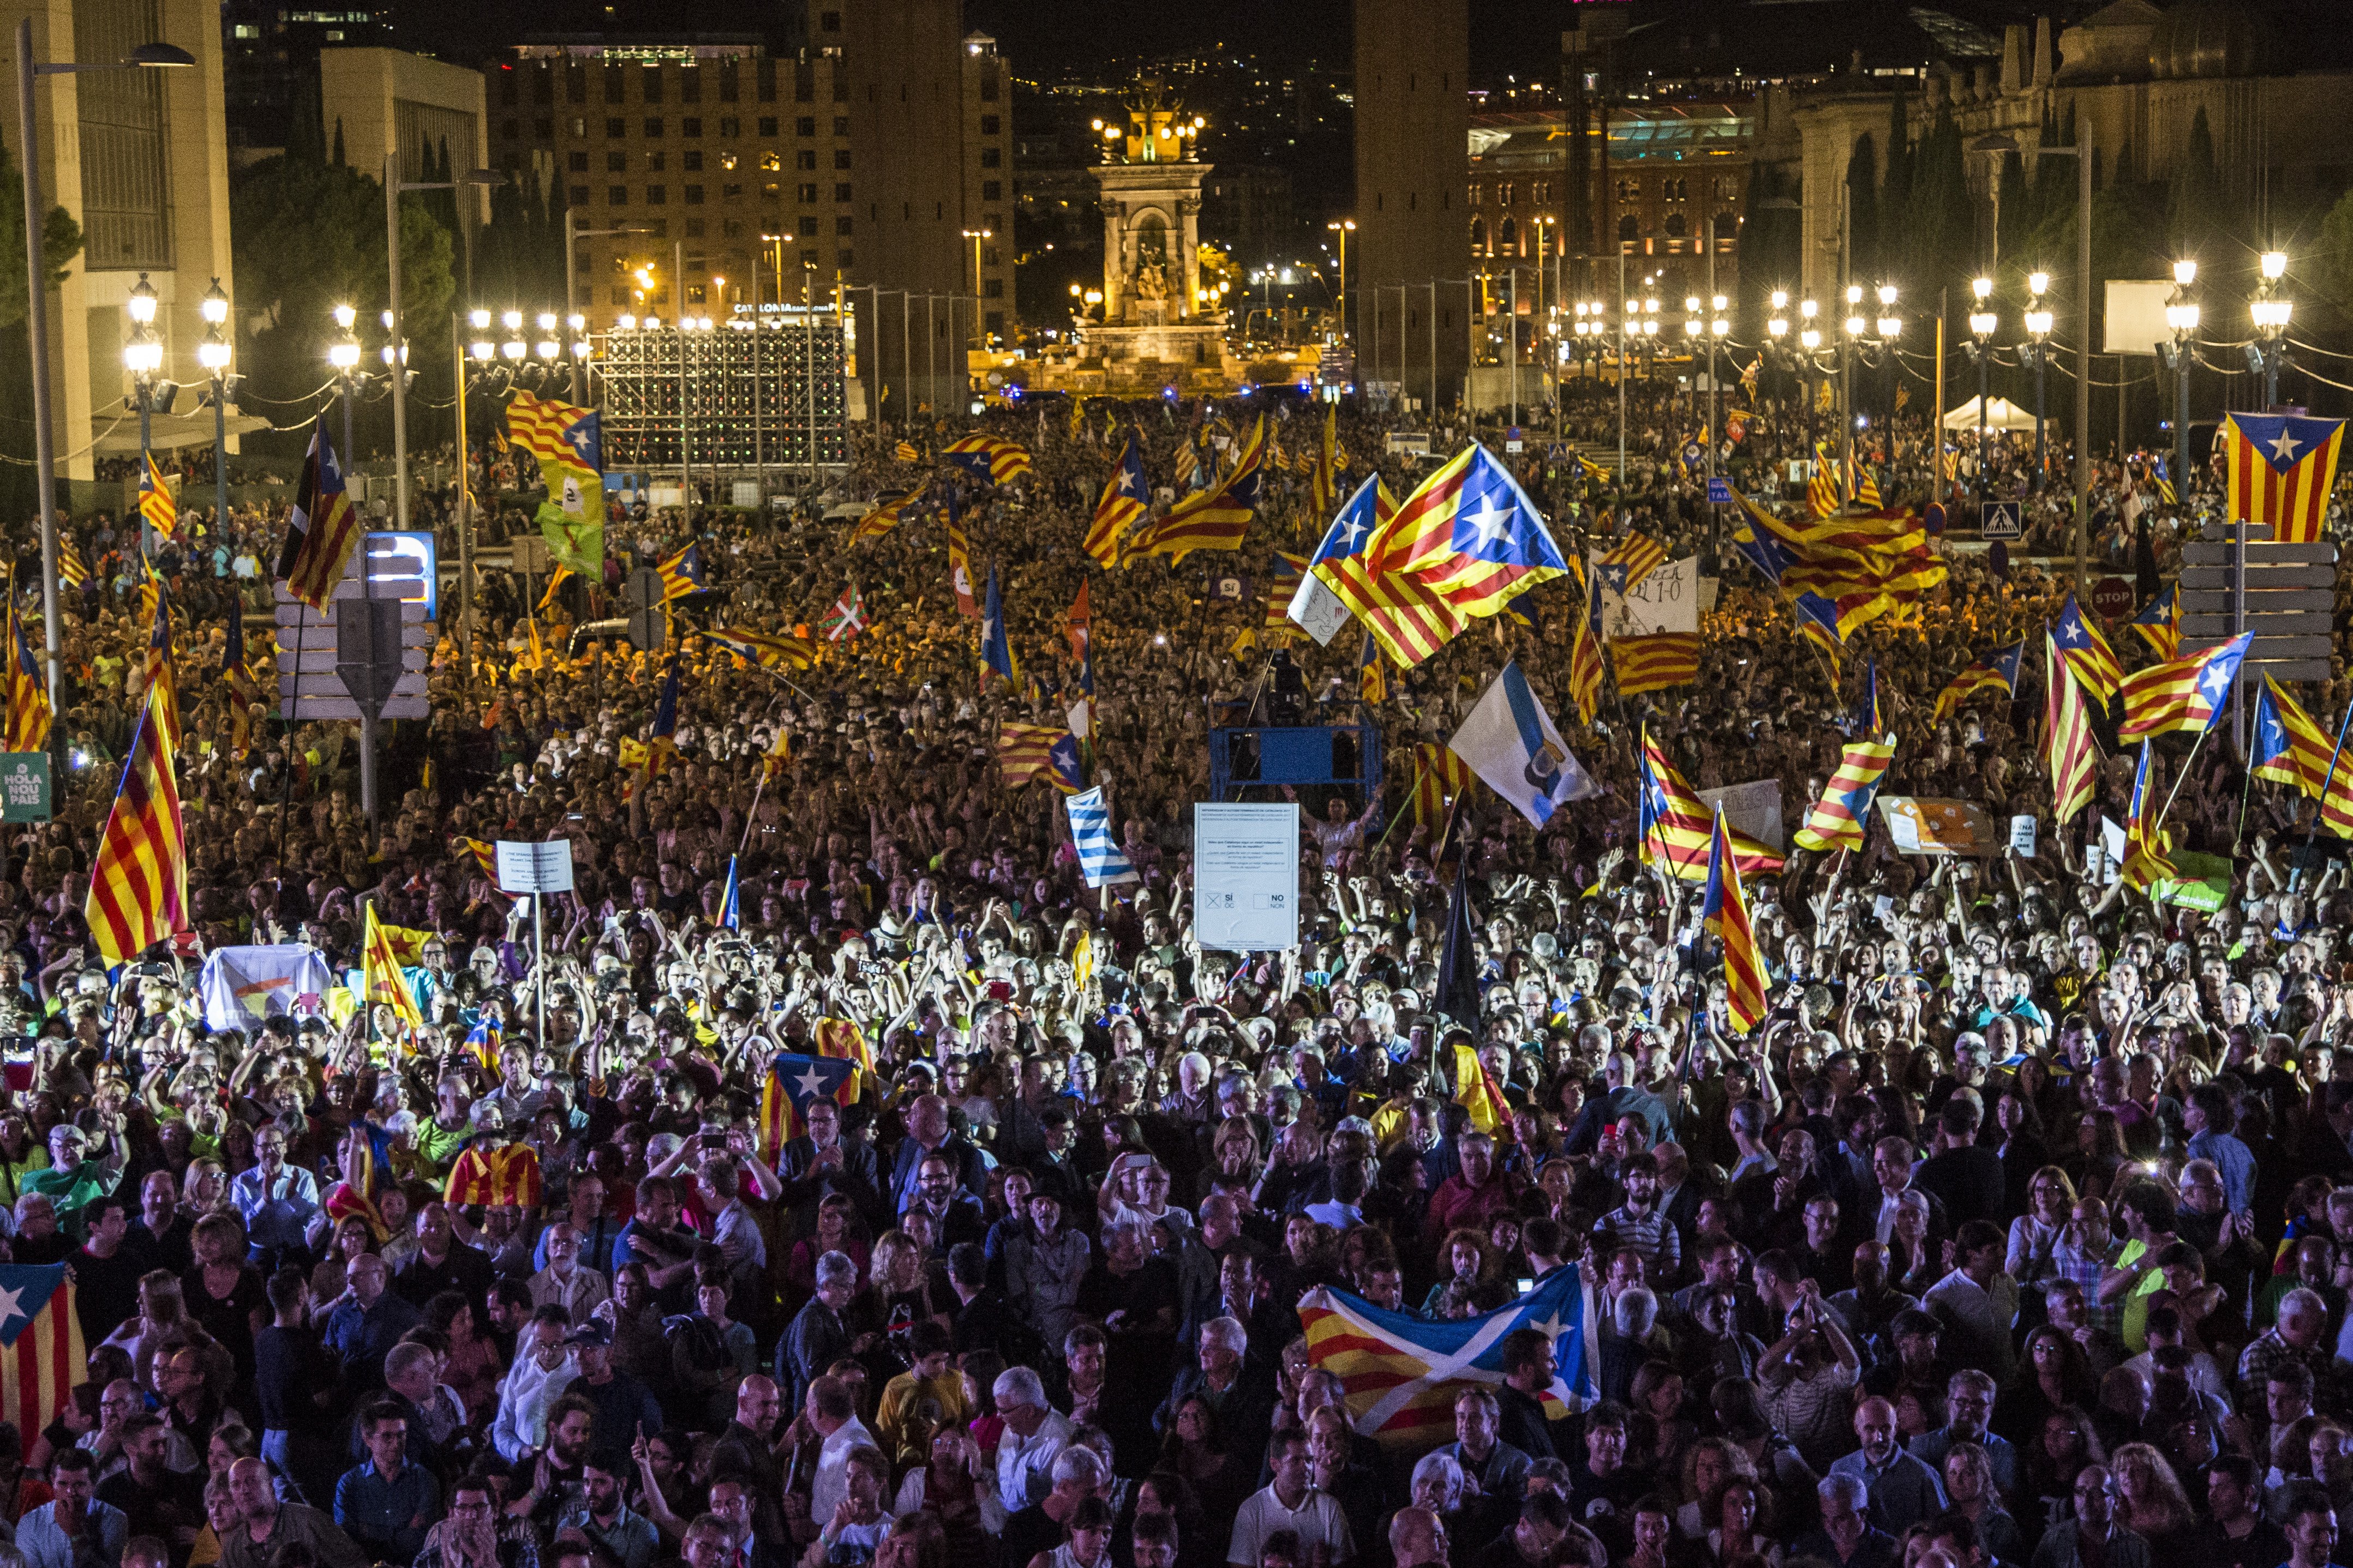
[0,371,2353,1568]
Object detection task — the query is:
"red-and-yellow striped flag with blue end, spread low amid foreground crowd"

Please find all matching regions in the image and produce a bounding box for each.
[1299,1267,1600,1453]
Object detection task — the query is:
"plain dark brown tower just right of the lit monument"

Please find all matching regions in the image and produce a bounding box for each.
[1348,0,1475,407]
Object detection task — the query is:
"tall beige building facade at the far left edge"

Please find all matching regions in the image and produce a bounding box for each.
[14,0,235,503]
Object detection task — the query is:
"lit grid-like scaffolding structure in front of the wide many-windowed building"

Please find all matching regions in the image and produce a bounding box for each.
[598,305,849,475]
